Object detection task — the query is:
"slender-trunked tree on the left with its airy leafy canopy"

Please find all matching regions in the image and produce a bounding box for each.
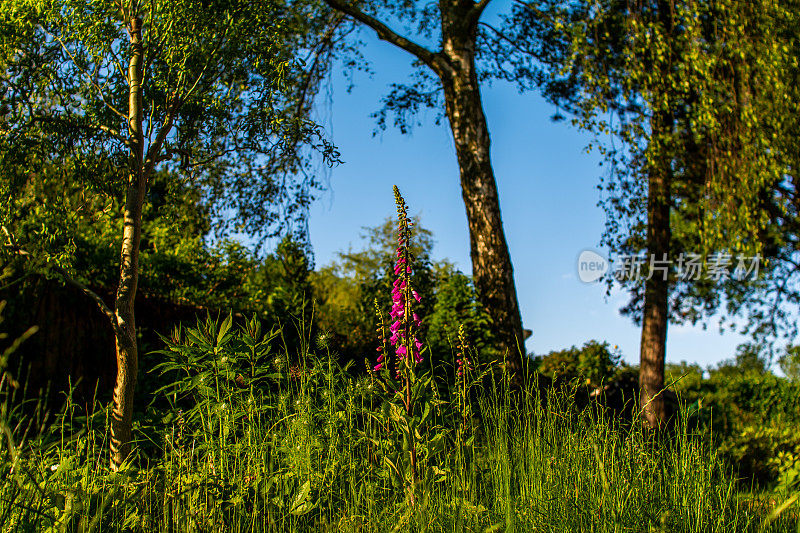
[0,0,332,469]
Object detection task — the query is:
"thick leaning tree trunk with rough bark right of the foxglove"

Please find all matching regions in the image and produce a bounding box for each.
[436,0,525,382]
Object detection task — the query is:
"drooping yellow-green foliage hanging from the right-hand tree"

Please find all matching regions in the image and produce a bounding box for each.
[544,0,797,250]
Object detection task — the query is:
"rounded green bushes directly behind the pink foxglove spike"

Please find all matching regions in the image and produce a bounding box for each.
[310,217,495,363]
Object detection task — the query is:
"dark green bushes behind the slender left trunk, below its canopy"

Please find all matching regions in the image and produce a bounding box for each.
[3,125,312,308]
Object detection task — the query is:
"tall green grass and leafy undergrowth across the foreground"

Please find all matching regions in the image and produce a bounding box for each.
[0,314,800,532]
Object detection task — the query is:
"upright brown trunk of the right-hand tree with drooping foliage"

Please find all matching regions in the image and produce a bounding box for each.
[639,113,672,428]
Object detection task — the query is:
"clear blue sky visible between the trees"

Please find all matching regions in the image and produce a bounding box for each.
[310,32,745,367]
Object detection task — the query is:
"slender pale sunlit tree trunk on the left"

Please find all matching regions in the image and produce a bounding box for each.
[111,14,147,470]
